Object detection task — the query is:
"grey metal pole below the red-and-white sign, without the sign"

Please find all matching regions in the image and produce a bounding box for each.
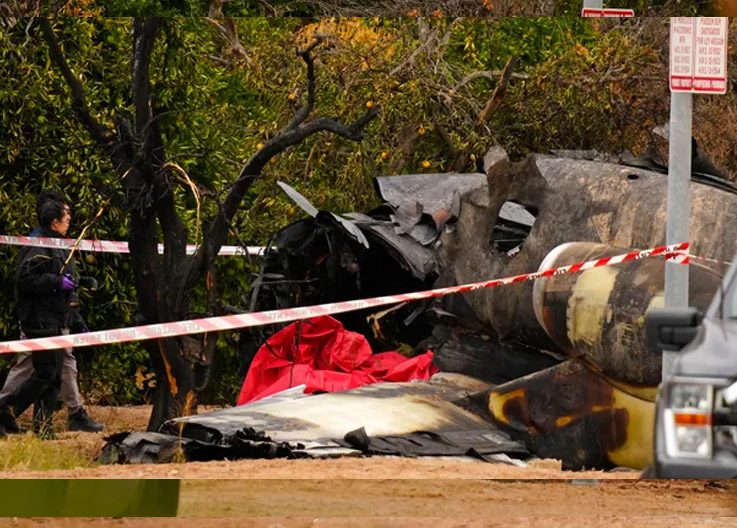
[663,92,693,379]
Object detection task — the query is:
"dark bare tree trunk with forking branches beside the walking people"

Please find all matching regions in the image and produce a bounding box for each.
[35,18,378,430]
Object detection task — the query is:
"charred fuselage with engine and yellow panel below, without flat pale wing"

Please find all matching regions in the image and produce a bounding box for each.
[243,148,737,468]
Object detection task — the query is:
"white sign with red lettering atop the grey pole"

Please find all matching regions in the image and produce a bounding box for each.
[670,17,729,94]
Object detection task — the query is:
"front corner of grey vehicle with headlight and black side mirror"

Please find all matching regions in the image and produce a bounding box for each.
[646,268,737,478]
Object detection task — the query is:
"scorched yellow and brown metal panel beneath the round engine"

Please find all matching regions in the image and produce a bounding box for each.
[487,361,657,469]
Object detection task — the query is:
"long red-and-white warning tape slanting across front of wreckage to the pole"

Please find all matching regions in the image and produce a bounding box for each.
[0,242,689,354]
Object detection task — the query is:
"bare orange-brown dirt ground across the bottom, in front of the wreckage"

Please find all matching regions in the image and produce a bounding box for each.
[0,407,737,528]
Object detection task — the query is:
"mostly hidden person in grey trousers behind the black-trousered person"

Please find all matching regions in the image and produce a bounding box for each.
[0,191,105,433]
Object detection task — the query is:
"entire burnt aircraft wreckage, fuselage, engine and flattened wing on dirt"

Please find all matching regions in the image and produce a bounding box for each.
[103,144,737,469]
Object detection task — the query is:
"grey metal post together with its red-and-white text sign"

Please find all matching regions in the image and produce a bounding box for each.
[662,17,728,379]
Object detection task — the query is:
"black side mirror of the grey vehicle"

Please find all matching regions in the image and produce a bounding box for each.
[645,307,703,352]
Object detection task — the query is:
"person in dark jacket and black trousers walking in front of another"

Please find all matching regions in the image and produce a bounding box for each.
[0,200,84,439]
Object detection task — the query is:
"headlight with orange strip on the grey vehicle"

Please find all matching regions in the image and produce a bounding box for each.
[664,383,714,458]
